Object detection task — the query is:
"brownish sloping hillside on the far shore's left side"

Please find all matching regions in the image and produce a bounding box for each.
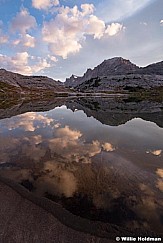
[0,69,66,96]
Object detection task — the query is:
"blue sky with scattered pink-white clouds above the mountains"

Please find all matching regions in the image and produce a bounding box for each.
[0,0,163,81]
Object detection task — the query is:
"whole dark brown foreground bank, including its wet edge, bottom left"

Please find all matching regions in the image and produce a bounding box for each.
[0,178,114,243]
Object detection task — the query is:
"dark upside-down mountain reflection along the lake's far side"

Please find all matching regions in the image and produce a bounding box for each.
[0,97,163,127]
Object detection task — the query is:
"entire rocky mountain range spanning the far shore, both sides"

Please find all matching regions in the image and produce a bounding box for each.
[0,57,163,97]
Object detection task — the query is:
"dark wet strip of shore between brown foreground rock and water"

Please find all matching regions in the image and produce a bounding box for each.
[0,177,121,242]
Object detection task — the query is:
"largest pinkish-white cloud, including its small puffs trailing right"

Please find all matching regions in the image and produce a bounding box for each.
[42,4,122,59]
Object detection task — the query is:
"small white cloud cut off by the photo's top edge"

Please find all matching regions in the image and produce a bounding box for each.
[32,0,59,10]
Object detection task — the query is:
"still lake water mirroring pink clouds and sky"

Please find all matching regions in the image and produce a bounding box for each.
[0,99,163,233]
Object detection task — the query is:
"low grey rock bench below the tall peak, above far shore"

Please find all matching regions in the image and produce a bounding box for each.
[76,74,163,92]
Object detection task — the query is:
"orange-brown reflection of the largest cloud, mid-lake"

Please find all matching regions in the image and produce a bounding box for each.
[48,126,101,163]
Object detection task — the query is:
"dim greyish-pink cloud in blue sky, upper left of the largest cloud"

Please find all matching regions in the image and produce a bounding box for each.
[11,8,37,34]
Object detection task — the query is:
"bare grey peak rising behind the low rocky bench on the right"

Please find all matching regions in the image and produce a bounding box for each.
[64,57,163,88]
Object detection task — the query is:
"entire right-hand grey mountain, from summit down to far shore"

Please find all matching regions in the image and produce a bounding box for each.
[65,57,163,92]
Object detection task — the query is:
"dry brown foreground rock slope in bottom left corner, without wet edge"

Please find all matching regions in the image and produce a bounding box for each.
[0,179,118,243]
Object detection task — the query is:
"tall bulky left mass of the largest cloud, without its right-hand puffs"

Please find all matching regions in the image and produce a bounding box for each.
[42,7,83,59]
